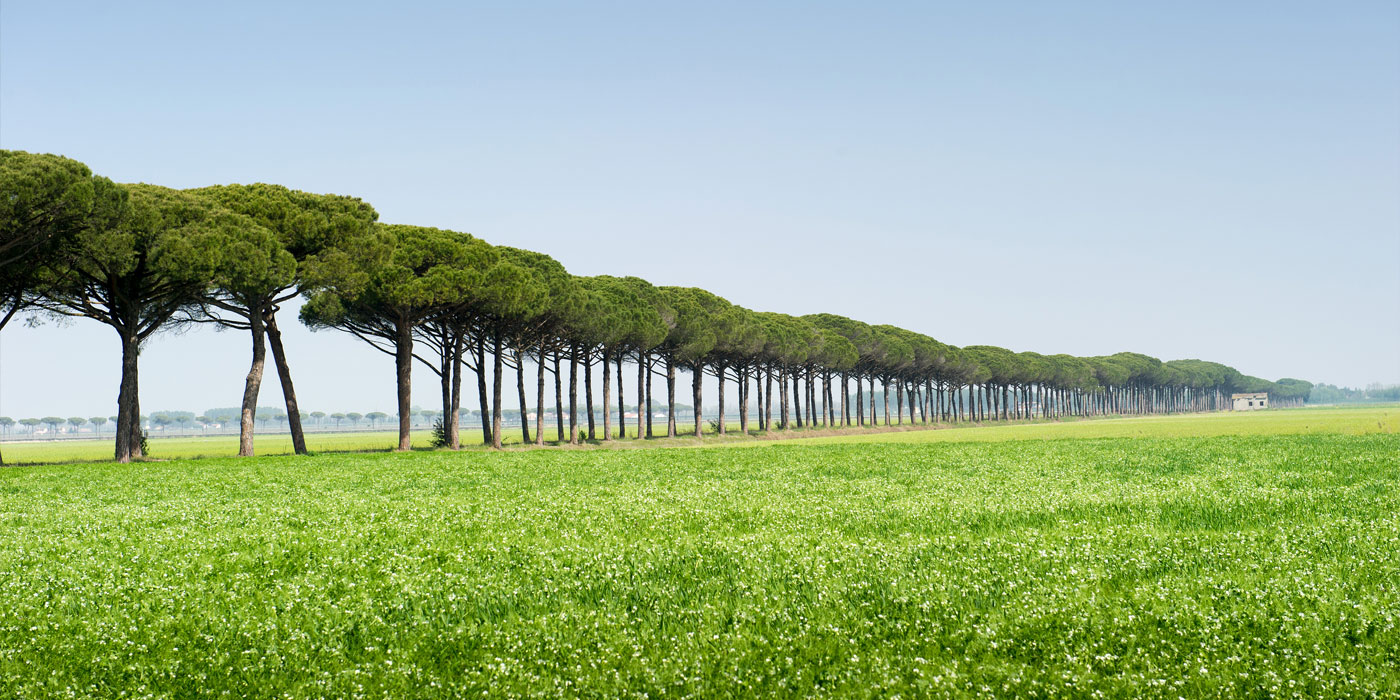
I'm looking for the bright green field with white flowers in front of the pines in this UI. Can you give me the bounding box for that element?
[0,407,1400,699]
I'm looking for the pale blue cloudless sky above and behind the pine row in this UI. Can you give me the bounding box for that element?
[0,0,1400,419]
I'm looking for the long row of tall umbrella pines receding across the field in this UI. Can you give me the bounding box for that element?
[0,151,1310,462]
